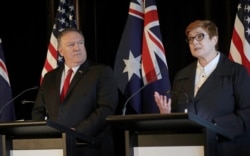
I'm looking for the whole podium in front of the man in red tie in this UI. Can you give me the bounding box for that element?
[0,120,93,156]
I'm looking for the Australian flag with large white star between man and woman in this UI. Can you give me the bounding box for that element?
[114,0,170,114]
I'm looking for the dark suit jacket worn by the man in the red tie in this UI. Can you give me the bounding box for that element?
[32,61,118,155]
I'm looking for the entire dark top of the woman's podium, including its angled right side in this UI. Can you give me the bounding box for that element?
[106,113,231,139]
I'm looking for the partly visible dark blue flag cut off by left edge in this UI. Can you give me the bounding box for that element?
[0,39,16,121]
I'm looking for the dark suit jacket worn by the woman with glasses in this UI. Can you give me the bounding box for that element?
[172,53,250,156]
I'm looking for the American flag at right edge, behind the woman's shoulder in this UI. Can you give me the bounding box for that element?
[229,0,250,74]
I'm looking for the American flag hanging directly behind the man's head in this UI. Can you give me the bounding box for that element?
[40,0,77,83]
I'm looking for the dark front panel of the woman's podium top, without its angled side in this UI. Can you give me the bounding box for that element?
[107,113,201,131]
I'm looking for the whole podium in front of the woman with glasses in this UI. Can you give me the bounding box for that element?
[106,113,230,156]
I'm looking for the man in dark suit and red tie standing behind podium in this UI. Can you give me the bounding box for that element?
[32,28,118,156]
